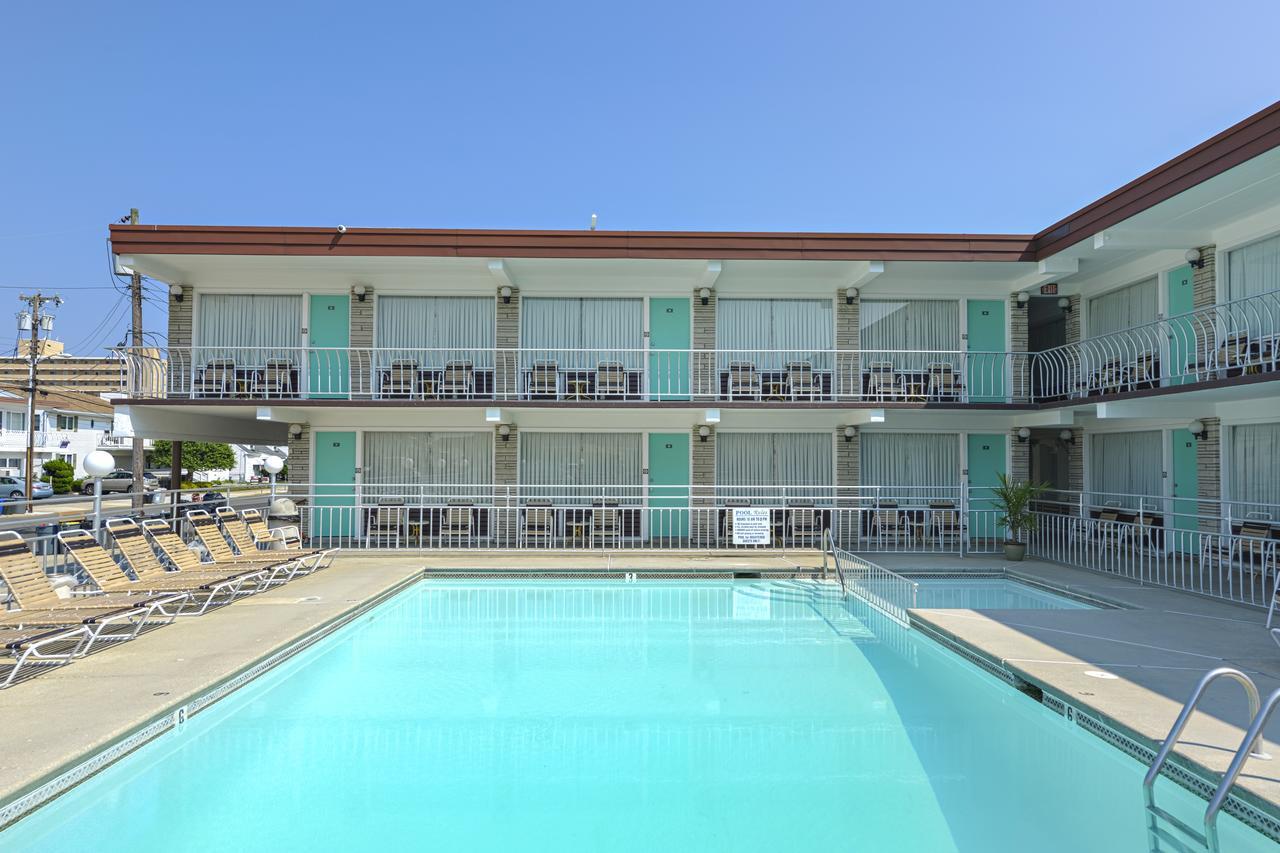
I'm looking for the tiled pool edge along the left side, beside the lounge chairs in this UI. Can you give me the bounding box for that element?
[0,573,422,833]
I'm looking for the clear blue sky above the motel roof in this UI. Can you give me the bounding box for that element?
[0,0,1280,352]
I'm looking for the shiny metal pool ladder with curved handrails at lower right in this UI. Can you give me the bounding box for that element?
[1142,666,1280,853]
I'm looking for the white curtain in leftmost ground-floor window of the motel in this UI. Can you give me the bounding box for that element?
[362,432,493,503]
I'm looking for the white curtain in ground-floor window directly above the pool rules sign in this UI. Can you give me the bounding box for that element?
[716,433,835,501]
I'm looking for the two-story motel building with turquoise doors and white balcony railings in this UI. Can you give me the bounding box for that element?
[111,105,1280,603]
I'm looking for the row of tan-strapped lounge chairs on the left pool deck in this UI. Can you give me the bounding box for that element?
[0,507,332,688]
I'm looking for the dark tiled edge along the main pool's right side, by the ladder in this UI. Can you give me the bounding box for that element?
[908,611,1280,843]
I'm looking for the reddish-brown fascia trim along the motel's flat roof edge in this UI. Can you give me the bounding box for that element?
[110,101,1280,263]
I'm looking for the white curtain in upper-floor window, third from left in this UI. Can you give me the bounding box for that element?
[520,297,644,370]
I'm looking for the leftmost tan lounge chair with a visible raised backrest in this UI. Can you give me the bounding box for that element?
[0,530,173,654]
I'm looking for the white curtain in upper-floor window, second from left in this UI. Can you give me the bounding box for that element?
[374,296,495,369]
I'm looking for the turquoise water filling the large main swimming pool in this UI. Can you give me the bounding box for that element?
[0,581,1274,853]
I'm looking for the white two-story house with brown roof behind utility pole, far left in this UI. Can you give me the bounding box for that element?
[0,387,111,476]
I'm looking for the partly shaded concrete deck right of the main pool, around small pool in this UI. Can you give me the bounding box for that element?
[868,555,1280,816]
